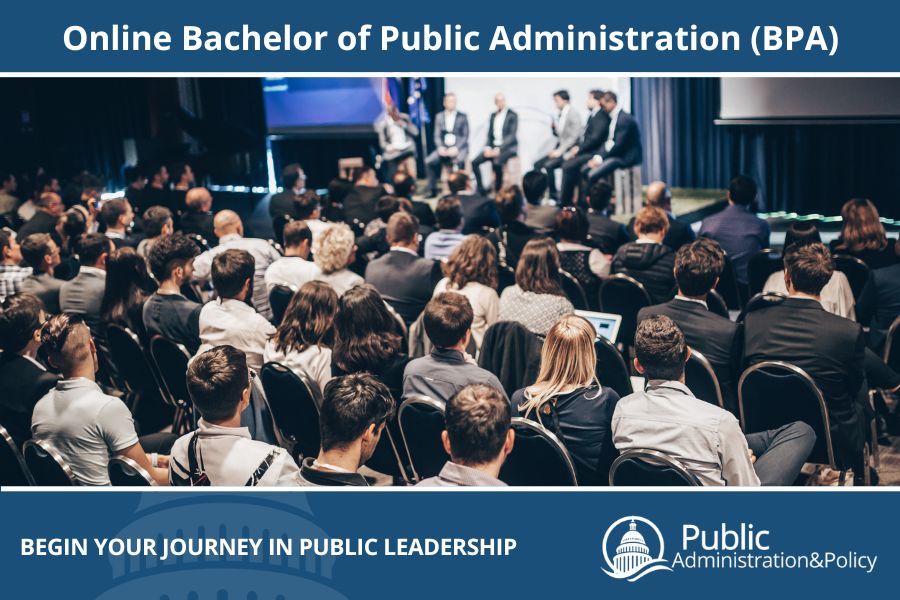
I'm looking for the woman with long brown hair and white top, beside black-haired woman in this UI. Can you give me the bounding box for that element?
[263,281,338,391]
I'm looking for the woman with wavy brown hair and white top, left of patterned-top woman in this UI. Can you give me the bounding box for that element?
[434,235,500,348]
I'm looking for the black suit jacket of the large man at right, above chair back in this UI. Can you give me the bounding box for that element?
[744,298,866,453]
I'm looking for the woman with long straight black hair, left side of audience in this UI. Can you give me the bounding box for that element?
[100,246,156,344]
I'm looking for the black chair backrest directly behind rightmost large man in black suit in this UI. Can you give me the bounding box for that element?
[738,361,839,469]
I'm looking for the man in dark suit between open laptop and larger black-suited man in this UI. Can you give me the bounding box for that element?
[638,238,737,414]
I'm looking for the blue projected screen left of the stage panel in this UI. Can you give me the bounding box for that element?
[262,77,384,135]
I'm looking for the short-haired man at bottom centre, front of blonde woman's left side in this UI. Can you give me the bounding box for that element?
[417,384,516,487]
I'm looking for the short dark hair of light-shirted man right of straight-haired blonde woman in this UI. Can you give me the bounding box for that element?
[634,315,688,381]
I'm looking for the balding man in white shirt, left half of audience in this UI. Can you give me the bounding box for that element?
[194,210,281,319]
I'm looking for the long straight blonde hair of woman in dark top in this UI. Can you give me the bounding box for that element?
[519,315,601,420]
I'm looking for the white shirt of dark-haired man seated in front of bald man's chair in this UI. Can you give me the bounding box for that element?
[197,298,275,371]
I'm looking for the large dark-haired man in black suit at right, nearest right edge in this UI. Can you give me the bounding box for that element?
[744,243,868,480]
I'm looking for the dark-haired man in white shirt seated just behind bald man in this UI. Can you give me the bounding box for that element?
[199,248,275,371]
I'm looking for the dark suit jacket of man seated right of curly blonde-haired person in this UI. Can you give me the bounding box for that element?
[366,250,443,324]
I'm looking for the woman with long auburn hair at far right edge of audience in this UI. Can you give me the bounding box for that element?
[831,198,898,269]
